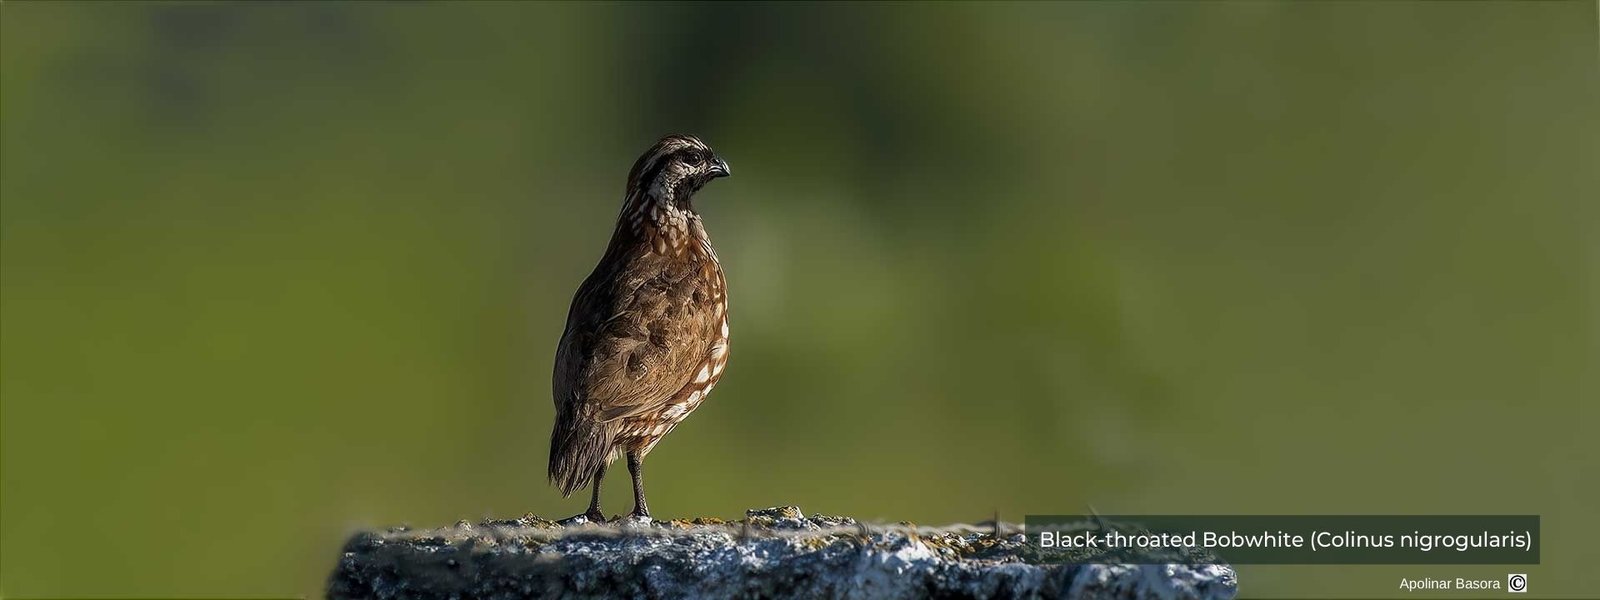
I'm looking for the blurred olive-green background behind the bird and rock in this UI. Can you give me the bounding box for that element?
[0,2,1600,597]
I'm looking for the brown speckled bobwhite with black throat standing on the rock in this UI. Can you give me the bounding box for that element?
[549,134,731,525]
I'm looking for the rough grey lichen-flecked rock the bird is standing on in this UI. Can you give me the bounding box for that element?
[328,507,1238,600]
